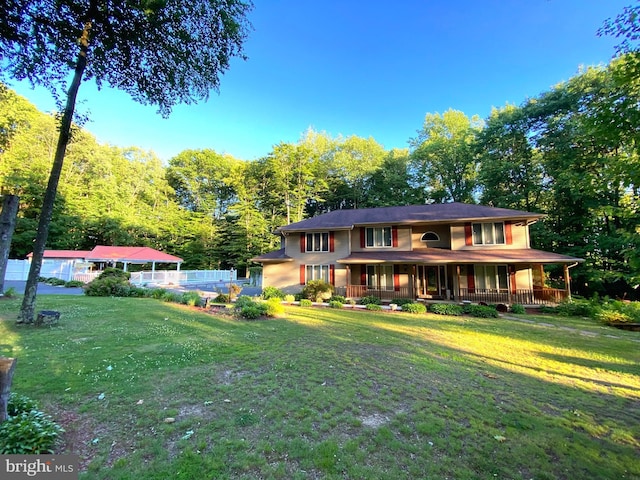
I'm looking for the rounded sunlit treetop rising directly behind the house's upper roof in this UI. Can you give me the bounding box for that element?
[409,109,482,203]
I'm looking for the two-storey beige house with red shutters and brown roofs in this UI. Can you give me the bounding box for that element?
[253,202,583,304]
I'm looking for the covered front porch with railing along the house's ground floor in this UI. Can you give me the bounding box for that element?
[336,248,578,305]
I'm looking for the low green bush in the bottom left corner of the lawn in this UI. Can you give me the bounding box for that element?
[0,393,64,455]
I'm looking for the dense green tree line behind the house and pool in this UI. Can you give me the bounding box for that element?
[0,52,640,298]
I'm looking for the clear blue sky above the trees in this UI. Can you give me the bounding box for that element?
[11,0,632,161]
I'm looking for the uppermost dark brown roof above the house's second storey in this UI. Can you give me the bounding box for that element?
[278,202,544,232]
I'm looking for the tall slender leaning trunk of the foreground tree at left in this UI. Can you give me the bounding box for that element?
[18,22,91,323]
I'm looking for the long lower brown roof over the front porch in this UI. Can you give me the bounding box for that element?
[337,248,584,265]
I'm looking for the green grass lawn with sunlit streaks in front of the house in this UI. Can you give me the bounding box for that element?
[0,296,640,480]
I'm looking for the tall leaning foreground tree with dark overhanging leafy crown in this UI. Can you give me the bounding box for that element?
[0,0,252,323]
